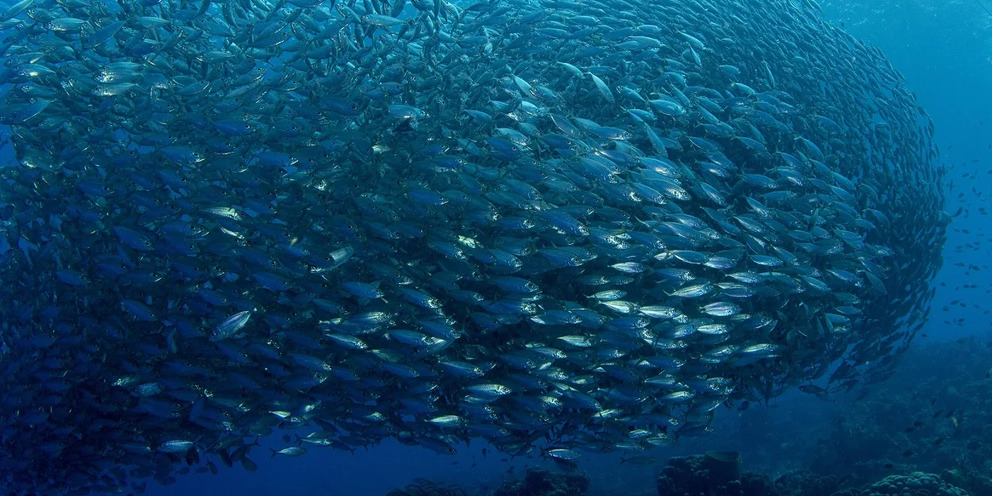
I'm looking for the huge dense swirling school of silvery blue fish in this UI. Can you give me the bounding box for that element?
[0,0,947,494]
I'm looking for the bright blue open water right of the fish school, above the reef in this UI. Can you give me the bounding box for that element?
[823,0,992,346]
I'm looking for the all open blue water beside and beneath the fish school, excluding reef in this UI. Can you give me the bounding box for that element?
[0,0,992,496]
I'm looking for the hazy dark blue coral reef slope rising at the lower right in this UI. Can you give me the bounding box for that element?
[808,339,992,484]
